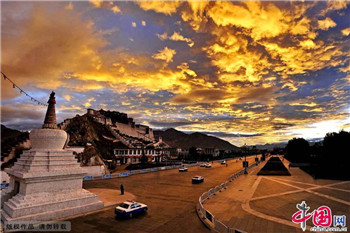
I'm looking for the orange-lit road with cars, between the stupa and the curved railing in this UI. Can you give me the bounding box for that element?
[69,157,260,233]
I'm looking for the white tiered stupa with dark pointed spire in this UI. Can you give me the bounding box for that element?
[1,92,103,222]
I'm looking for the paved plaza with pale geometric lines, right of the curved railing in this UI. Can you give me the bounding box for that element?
[204,158,350,233]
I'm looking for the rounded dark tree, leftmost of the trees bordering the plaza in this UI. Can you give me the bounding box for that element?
[286,138,310,163]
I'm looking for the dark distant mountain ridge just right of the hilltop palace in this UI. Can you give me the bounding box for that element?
[153,128,239,150]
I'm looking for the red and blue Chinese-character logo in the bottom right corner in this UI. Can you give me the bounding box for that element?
[292,201,347,232]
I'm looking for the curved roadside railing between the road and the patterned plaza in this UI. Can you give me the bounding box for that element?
[197,163,257,233]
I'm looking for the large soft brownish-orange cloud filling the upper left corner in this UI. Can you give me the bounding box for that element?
[1,2,107,95]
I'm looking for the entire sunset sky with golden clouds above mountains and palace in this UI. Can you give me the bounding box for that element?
[1,1,350,145]
